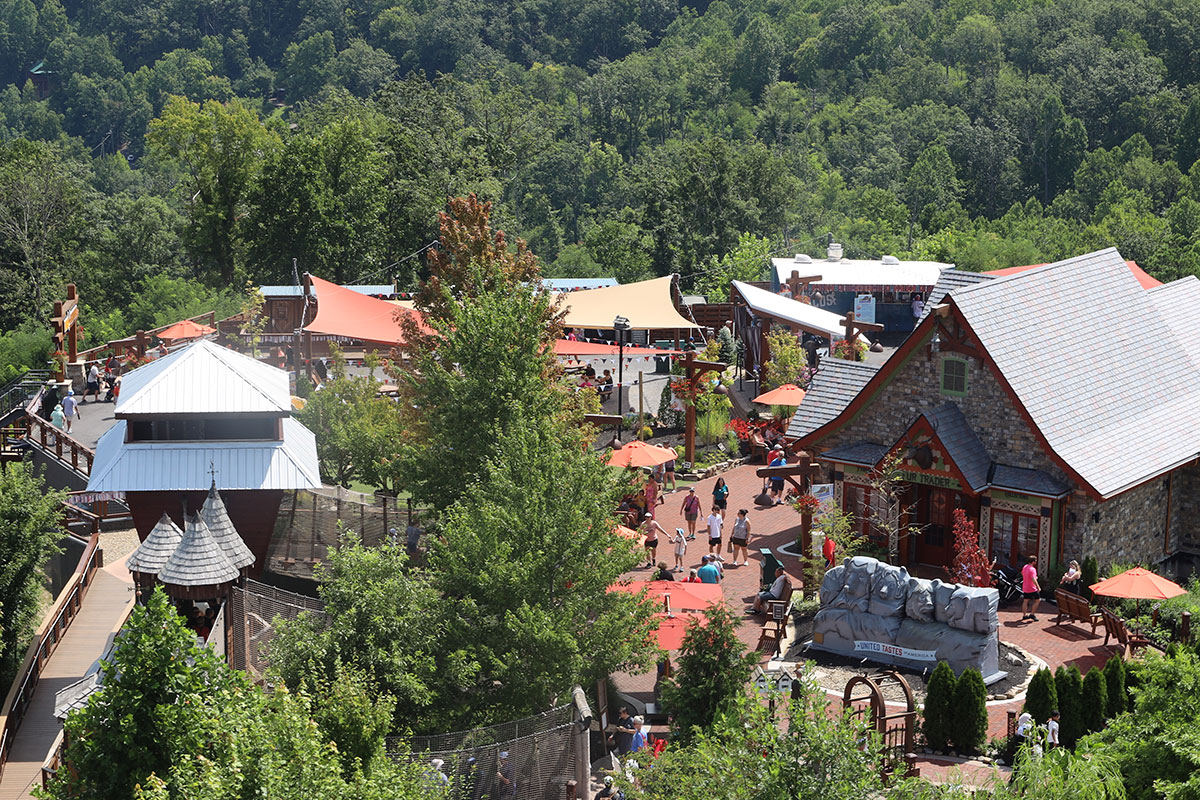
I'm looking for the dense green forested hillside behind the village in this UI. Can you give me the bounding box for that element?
[0,0,1200,365]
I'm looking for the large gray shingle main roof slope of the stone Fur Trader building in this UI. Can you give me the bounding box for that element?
[949,248,1200,498]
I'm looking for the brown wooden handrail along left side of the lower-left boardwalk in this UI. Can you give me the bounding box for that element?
[0,533,104,775]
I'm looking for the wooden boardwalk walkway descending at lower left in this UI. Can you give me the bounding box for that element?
[0,570,133,800]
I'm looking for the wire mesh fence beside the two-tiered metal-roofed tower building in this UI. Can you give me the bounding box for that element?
[266,487,414,578]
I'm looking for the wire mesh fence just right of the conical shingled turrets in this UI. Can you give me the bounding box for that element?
[223,581,325,681]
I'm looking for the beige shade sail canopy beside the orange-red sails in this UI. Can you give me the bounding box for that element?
[563,276,701,331]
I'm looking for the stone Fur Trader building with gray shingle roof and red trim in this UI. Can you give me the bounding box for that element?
[790,248,1200,575]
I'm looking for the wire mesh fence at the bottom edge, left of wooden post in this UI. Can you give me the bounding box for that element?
[388,704,580,800]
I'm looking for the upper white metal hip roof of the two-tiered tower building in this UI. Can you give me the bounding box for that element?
[114,339,292,419]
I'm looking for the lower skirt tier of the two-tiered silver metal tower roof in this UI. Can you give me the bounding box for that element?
[88,416,320,492]
